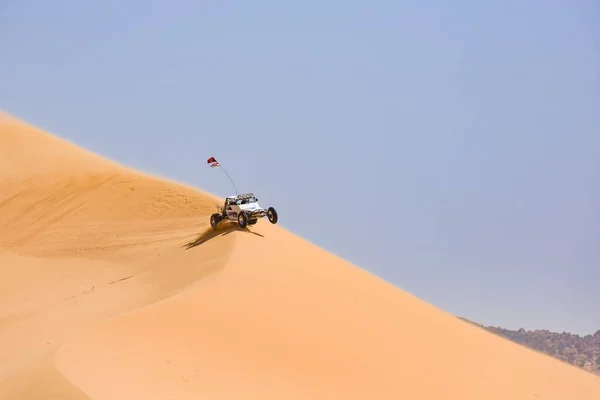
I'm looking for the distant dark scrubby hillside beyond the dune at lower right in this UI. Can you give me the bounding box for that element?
[459,317,600,375]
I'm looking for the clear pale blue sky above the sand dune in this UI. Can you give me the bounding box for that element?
[0,0,600,334]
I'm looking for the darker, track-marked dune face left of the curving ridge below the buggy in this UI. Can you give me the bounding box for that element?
[0,116,234,399]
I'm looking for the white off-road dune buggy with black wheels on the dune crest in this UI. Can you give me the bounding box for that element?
[210,193,278,230]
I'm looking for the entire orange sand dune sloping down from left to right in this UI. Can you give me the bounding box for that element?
[0,111,600,400]
